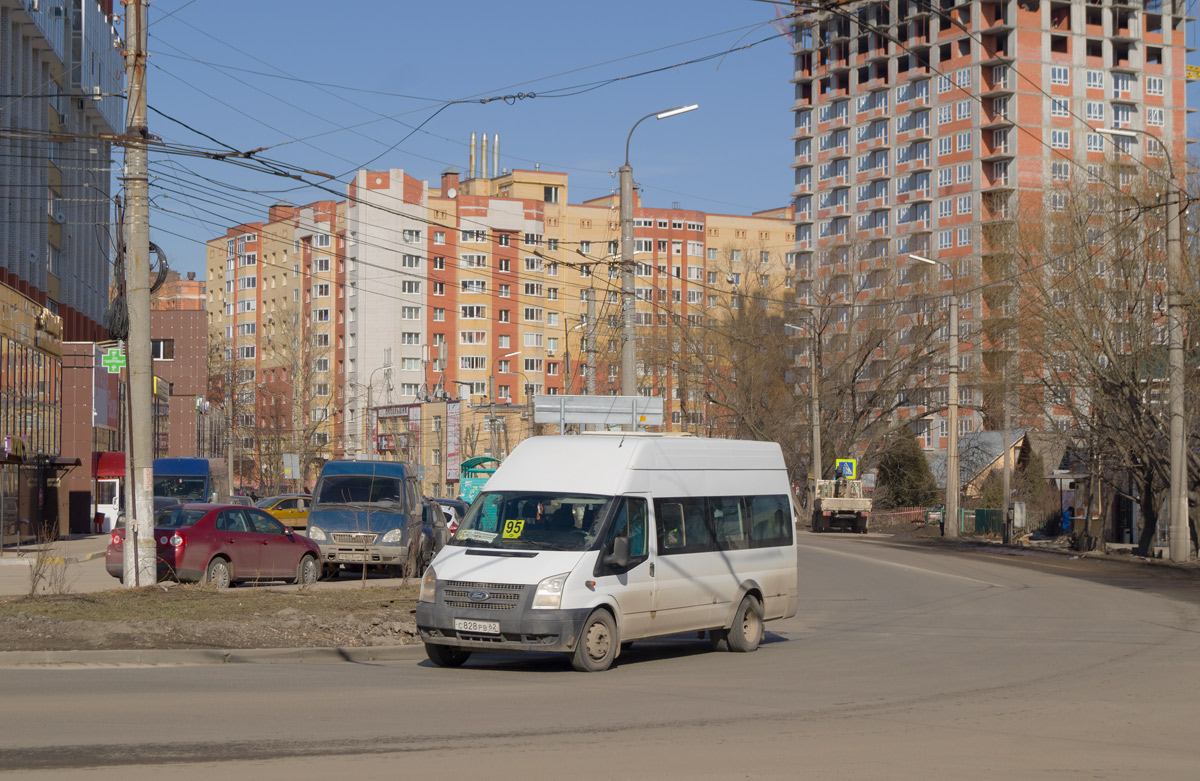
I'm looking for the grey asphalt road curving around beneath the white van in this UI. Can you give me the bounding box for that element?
[0,534,1200,780]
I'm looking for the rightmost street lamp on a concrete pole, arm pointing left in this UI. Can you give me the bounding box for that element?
[1093,127,1192,561]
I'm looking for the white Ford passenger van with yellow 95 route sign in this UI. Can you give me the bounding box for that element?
[416,433,798,671]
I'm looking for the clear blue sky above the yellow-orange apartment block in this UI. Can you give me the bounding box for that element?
[148,0,792,276]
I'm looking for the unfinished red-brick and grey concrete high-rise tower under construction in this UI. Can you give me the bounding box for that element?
[792,0,1188,450]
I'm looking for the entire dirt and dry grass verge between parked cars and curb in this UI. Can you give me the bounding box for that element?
[0,585,418,651]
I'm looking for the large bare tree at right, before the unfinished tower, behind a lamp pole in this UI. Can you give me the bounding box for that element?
[1012,160,1200,555]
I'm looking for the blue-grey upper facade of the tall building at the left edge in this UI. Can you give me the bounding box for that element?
[0,0,124,341]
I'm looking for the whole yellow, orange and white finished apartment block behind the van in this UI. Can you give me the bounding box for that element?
[208,146,794,488]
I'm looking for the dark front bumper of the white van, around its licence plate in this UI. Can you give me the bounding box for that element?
[416,592,592,651]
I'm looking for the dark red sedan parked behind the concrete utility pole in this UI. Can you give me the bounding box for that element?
[104,504,320,588]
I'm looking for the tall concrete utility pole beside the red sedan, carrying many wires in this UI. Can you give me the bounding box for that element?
[124,0,157,588]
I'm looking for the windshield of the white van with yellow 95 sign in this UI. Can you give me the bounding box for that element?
[449,491,613,551]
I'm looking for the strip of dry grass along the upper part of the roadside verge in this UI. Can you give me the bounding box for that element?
[0,585,416,621]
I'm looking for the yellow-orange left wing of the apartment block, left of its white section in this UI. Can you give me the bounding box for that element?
[205,200,353,485]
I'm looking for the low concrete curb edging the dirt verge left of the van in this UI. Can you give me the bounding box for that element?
[0,644,425,668]
